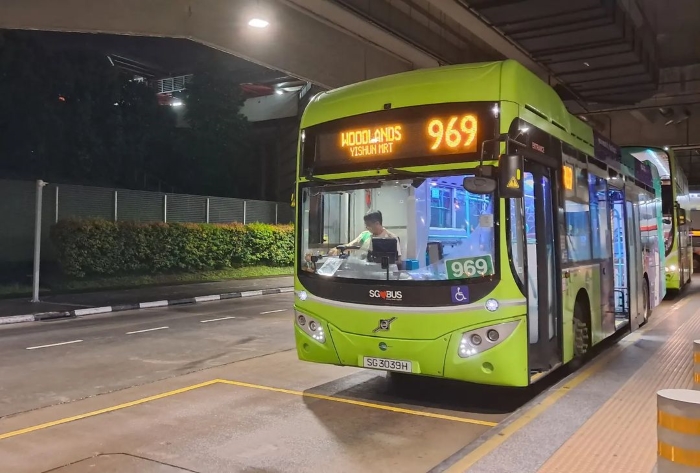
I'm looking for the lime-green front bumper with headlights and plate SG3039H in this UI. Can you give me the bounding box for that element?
[295,316,530,386]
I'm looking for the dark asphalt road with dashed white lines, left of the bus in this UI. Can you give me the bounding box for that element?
[0,294,294,417]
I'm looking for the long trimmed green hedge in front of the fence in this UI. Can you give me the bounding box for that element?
[51,220,294,278]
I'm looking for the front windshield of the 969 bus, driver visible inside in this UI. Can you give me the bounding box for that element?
[299,175,496,282]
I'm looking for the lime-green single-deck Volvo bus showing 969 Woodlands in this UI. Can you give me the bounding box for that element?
[294,60,661,387]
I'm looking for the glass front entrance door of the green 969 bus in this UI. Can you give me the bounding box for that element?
[524,161,561,373]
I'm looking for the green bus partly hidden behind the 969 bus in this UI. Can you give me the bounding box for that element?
[622,146,693,296]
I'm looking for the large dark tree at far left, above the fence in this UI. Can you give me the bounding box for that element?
[0,33,175,187]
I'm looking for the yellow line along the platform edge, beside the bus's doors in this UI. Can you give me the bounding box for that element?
[445,299,688,473]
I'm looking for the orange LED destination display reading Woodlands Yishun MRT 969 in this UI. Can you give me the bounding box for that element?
[303,103,496,170]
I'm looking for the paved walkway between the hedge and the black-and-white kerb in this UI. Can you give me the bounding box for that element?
[0,276,293,317]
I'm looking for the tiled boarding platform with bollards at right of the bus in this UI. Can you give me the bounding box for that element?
[431,282,700,473]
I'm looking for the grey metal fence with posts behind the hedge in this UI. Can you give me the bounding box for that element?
[0,179,294,263]
